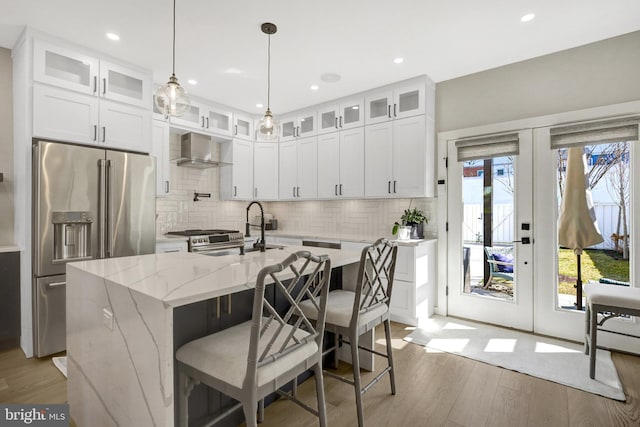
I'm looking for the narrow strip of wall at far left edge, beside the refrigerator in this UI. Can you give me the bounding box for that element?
[0,48,14,246]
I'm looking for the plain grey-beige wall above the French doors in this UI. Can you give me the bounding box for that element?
[436,31,640,132]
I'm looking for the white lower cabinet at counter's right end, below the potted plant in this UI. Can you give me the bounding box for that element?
[390,240,437,326]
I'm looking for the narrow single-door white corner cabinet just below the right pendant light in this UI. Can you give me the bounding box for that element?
[253,142,278,200]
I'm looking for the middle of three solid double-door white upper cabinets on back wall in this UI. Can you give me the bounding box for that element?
[318,127,365,199]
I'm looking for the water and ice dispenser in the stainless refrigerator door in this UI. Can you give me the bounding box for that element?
[51,211,93,264]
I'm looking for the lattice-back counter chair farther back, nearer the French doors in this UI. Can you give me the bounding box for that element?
[300,239,398,427]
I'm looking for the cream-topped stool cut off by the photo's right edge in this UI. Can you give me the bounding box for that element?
[584,283,640,379]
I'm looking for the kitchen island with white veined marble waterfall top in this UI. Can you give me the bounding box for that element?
[67,246,360,427]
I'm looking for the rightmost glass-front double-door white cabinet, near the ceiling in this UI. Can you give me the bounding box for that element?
[365,79,425,125]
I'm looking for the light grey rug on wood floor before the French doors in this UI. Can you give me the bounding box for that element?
[405,316,625,401]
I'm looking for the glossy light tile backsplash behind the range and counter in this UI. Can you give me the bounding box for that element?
[156,135,437,237]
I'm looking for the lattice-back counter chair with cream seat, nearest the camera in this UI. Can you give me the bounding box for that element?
[176,251,331,427]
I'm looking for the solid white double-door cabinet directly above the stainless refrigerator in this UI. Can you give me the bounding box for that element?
[33,83,151,153]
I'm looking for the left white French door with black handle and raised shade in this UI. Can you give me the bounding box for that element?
[447,129,534,331]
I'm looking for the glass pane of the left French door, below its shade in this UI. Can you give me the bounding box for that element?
[462,157,515,301]
